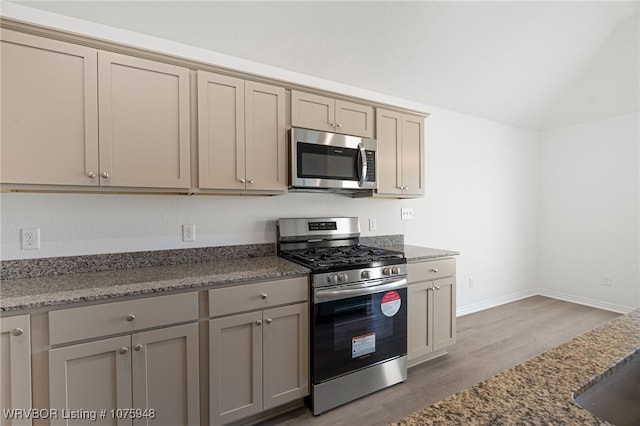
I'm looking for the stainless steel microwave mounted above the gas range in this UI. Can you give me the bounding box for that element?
[289,127,377,190]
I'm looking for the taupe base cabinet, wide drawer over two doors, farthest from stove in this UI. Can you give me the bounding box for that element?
[48,292,200,426]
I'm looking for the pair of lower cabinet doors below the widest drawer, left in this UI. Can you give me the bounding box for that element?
[49,323,199,426]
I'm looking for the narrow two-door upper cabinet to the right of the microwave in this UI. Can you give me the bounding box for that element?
[376,108,424,198]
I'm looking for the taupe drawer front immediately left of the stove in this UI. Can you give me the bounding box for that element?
[209,277,309,317]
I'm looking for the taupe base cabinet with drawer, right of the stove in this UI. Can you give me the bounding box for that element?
[407,259,456,366]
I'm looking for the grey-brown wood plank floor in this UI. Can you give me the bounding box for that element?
[264,296,620,426]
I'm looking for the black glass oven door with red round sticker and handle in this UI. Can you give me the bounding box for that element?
[311,278,407,384]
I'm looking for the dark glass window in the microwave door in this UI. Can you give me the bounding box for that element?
[296,142,359,180]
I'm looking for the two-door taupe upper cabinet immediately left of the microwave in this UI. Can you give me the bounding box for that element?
[198,71,287,193]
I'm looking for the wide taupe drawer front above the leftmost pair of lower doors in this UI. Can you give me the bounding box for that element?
[49,292,198,345]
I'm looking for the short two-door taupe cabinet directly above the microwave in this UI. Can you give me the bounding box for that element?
[291,90,374,138]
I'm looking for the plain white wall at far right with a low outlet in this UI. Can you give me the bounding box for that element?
[540,113,640,311]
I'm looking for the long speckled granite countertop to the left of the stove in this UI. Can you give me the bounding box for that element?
[0,256,309,315]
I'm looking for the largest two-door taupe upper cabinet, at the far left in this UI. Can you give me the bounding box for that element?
[1,30,191,188]
